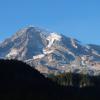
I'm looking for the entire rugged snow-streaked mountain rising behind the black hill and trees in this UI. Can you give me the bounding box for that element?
[0,26,100,75]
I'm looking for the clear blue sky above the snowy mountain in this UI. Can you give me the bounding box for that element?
[0,0,100,45]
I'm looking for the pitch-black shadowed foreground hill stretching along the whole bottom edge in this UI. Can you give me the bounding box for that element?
[0,60,100,100]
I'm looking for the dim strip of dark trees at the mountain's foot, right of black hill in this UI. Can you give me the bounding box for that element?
[48,72,100,88]
